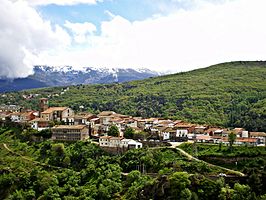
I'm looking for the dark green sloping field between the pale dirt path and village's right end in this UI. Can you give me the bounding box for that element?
[180,143,266,176]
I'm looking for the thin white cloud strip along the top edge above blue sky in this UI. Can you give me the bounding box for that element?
[27,0,99,6]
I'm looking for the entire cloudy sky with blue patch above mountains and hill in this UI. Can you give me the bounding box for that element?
[0,0,266,78]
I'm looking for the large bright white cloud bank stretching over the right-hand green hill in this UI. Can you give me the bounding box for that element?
[38,0,266,71]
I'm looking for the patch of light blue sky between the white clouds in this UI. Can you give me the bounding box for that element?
[37,0,193,32]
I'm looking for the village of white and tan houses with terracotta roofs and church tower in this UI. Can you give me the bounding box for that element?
[0,98,266,149]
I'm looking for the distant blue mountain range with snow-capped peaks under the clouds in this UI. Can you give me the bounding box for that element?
[0,66,160,92]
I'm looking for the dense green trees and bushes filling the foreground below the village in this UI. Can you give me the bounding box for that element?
[0,126,266,200]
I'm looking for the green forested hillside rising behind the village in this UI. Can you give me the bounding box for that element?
[1,62,266,131]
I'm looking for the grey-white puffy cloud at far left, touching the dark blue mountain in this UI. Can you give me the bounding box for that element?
[0,0,70,78]
